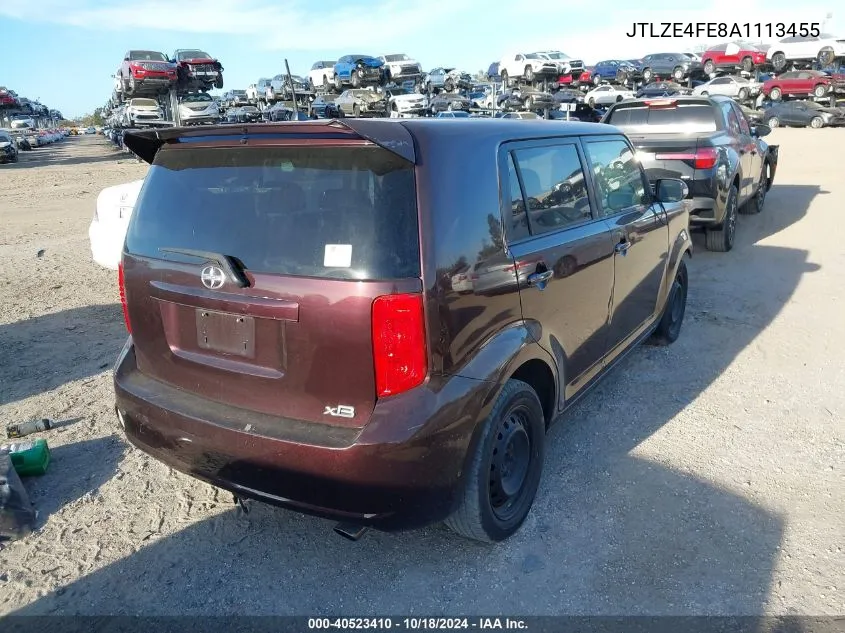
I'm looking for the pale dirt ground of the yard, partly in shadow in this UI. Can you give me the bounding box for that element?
[0,129,845,615]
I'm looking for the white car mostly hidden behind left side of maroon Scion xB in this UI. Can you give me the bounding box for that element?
[88,179,144,270]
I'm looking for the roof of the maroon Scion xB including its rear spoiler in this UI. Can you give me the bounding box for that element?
[124,117,620,163]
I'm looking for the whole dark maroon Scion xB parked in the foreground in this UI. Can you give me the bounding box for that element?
[114,119,691,541]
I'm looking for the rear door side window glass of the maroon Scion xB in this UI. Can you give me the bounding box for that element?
[512,143,592,235]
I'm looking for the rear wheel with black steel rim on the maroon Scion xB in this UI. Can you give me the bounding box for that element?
[444,379,546,543]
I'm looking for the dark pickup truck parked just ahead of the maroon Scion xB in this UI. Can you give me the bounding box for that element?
[602,95,778,252]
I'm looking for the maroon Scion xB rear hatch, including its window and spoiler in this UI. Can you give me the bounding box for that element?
[122,121,422,427]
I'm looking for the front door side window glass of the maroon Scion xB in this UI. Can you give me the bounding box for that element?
[586,139,646,216]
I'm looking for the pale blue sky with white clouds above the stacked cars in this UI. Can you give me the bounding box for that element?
[0,0,845,118]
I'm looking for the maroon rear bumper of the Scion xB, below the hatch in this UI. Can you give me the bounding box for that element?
[114,339,484,531]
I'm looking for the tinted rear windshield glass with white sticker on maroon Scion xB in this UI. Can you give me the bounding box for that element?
[126,145,420,279]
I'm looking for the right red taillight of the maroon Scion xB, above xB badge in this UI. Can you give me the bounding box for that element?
[372,294,428,398]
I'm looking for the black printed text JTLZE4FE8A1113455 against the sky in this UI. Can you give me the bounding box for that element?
[625,22,821,39]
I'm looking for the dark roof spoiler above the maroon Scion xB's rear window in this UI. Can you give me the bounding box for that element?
[123,119,417,164]
